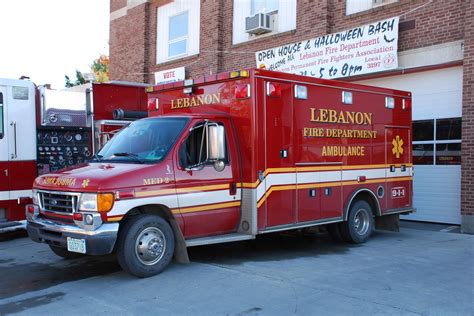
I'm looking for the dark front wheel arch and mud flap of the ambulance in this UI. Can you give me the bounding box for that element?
[119,204,189,263]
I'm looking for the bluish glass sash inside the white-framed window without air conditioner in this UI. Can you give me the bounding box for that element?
[168,12,188,58]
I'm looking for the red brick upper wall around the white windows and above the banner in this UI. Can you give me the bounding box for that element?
[110,0,466,82]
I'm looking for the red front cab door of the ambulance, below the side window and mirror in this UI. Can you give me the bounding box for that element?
[175,119,241,239]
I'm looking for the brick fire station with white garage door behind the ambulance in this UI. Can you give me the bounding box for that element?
[110,0,474,233]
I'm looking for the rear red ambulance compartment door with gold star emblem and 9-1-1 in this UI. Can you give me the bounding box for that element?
[385,127,412,212]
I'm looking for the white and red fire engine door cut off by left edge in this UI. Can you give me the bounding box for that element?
[0,87,10,222]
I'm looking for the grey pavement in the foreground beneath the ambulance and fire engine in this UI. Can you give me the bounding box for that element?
[0,222,474,316]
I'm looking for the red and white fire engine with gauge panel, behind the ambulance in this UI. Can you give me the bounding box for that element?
[0,79,147,232]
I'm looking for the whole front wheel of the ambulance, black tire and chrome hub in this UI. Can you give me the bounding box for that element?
[117,214,175,278]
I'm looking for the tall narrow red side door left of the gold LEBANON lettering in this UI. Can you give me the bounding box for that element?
[264,81,296,227]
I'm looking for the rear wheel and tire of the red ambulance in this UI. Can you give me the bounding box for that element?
[340,200,374,244]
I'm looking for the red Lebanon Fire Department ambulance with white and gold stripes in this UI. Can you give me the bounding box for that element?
[26,69,413,277]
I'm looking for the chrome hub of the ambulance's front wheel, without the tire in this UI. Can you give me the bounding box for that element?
[135,227,166,265]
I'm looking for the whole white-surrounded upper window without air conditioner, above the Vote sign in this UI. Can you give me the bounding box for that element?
[156,0,201,64]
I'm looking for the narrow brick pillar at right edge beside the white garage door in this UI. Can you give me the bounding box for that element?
[461,1,474,233]
